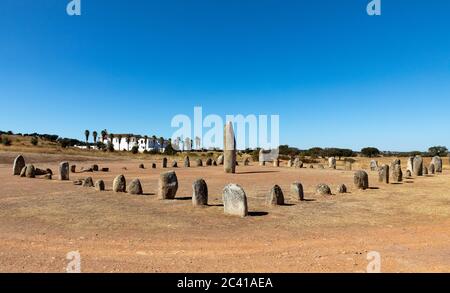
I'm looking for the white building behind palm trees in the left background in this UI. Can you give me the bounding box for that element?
[100,134,168,153]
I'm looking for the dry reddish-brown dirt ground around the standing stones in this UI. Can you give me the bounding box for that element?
[0,152,450,272]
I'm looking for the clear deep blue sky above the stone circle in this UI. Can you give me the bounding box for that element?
[0,0,450,150]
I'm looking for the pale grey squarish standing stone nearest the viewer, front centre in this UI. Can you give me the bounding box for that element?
[222,184,248,217]
